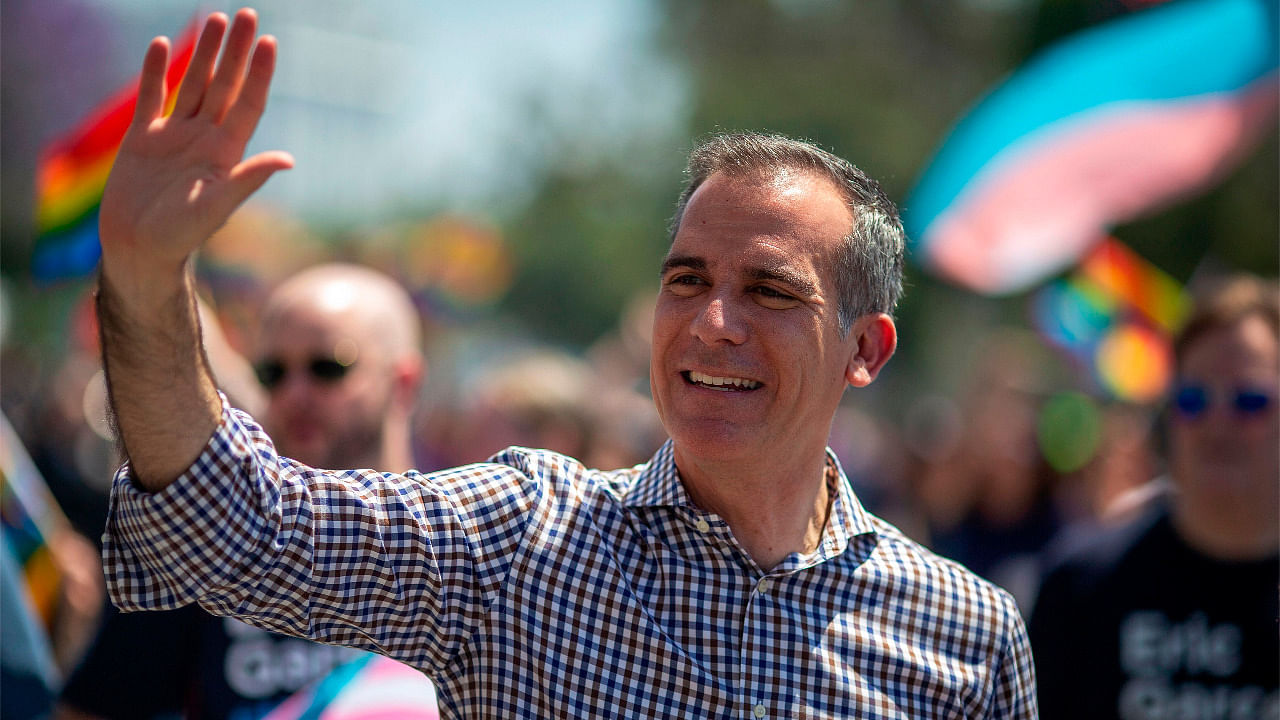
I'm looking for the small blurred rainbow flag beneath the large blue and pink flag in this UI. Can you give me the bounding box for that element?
[1032,238,1190,402]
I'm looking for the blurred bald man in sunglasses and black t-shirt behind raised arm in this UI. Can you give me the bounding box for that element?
[58,264,434,720]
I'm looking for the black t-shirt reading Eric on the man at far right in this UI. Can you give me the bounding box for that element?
[1029,509,1280,720]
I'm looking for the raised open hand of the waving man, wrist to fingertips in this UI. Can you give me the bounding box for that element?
[99,8,293,292]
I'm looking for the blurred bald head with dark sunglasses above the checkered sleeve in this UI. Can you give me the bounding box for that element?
[253,264,425,471]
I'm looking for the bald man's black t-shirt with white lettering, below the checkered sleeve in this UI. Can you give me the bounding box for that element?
[61,606,360,720]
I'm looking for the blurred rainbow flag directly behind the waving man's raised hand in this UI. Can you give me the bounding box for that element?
[31,23,198,282]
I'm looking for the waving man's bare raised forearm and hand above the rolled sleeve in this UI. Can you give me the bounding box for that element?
[97,9,293,491]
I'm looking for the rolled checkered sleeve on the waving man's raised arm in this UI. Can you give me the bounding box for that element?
[102,397,541,670]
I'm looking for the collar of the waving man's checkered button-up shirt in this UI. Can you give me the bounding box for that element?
[625,439,876,545]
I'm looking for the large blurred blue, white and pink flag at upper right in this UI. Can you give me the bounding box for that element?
[904,0,1280,293]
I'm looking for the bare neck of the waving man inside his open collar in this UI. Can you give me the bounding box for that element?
[676,448,832,570]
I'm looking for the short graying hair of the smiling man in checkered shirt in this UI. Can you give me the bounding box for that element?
[669,133,906,332]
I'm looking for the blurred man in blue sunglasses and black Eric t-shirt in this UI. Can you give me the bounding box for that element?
[1030,275,1280,720]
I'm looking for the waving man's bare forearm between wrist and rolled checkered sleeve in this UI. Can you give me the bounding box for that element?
[97,257,221,491]
